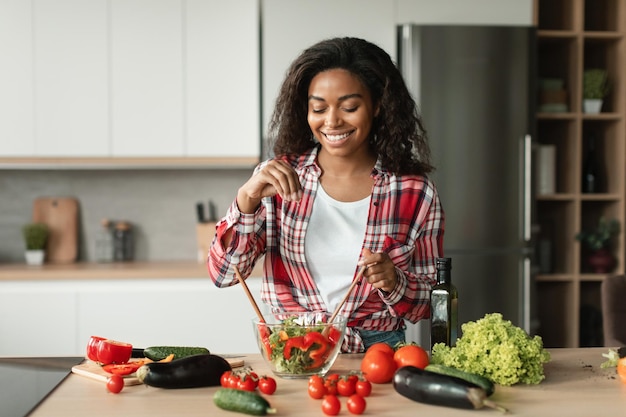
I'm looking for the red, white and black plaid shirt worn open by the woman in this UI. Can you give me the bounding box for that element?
[207,149,444,352]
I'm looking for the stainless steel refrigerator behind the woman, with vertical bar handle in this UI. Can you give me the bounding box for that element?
[398,25,538,334]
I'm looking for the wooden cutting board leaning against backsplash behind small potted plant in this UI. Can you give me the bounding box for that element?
[33,197,78,263]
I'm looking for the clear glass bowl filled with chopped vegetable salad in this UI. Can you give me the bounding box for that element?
[253,312,346,378]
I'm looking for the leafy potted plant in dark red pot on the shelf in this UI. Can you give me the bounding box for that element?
[576,217,620,274]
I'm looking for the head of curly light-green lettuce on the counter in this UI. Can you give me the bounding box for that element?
[431,313,550,386]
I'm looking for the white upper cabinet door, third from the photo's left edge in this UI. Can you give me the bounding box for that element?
[110,0,185,156]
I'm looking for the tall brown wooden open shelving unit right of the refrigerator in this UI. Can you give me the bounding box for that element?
[534,0,626,347]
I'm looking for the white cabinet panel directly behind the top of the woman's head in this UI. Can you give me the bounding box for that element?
[262,0,396,136]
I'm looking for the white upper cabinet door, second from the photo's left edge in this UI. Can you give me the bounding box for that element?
[33,0,109,156]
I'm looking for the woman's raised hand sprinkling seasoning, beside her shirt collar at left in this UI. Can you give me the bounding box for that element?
[237,159,302,213]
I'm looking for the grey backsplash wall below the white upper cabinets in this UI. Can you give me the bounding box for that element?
[0,169,252,263]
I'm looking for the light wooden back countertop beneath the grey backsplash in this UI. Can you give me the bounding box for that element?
[0,259,263,282]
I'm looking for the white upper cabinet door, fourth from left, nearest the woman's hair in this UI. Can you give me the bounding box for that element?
[185,0,261,158]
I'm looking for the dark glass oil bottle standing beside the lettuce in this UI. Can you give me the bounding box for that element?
[430,258,459,351]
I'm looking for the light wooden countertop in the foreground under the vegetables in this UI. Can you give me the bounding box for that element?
[24,348,626,417]
